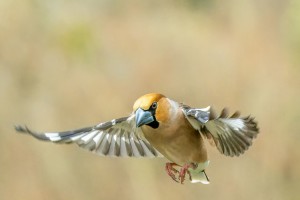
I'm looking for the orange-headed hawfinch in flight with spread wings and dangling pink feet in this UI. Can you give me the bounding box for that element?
[15,93,259,184]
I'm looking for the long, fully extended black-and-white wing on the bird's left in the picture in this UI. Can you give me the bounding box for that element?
[15,115,161,157]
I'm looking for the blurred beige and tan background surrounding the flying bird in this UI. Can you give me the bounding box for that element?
[0,0,300,200]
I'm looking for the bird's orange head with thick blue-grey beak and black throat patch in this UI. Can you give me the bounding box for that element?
[133,93,169,128]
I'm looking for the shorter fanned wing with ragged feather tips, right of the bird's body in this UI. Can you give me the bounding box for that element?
[182,106,259,156]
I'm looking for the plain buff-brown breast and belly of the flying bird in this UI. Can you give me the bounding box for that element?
[142,112,207,165]
